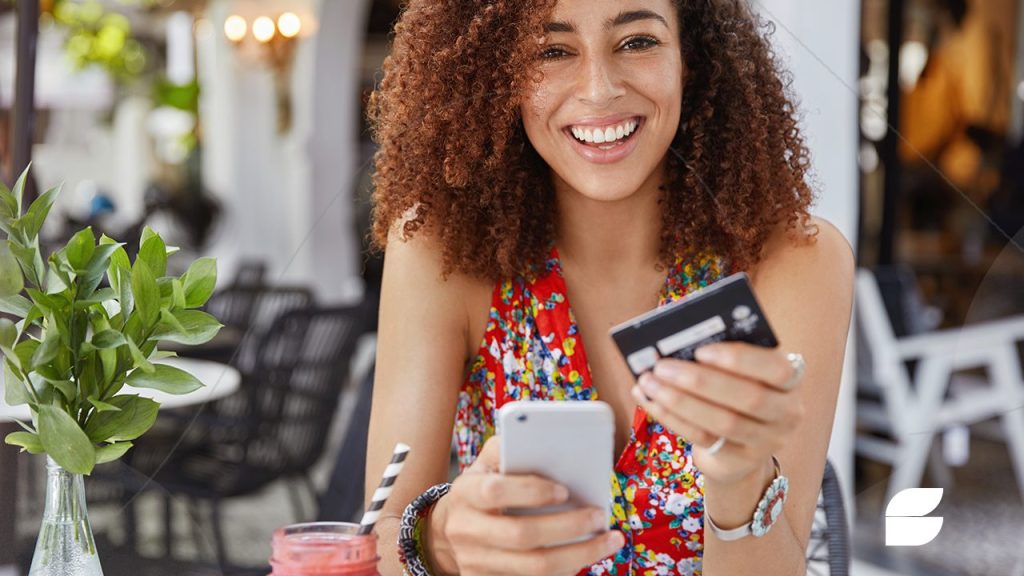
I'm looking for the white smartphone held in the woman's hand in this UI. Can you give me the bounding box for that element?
[497,401,615,517]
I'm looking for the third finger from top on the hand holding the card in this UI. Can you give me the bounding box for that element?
[640,373,767,445]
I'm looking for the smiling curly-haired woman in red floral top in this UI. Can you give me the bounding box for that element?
[367,0,853,576]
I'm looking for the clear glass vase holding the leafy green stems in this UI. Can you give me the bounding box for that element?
[29,456,103,576]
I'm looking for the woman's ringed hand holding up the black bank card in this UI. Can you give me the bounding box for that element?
[633,342,804,484]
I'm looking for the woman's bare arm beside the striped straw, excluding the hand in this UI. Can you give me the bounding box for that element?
[366,226,468,574]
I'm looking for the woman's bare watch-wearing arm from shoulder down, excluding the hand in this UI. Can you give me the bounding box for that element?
[705,216,853,575]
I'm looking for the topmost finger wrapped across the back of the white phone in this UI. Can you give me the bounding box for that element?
[465,474,569,511]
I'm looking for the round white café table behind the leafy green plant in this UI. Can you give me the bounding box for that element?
[0,358,242,576]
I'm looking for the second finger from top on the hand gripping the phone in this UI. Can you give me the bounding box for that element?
[463,507,610,551]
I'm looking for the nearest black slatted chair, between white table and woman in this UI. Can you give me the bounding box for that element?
[132,306,365,567]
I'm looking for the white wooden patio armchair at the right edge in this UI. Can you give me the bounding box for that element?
[855,269,1024,502]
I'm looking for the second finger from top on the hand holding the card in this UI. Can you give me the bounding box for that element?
[653,359,793,422]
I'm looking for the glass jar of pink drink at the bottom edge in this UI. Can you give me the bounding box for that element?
[270,522,380,576]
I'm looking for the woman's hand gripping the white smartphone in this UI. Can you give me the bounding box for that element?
[424,437,625,576]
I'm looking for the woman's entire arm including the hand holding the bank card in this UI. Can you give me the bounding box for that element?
[634,217,853,576]
